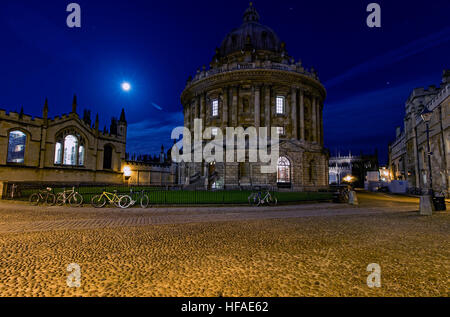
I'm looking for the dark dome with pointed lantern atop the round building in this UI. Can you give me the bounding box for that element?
[219,3,281,56]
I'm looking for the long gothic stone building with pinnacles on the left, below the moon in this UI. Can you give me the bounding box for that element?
[0,97,127,197]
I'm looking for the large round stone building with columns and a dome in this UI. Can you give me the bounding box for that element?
[179,4,328,191]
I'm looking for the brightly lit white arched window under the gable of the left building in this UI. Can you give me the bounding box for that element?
[54,129,85,166]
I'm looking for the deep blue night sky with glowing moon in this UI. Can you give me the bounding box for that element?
[0,0,450,162]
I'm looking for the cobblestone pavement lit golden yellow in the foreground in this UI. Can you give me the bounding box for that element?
[0,193,450,297]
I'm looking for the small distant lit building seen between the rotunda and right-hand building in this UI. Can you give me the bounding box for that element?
[328,151,379,187]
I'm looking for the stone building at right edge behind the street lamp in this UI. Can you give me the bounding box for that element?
[389,70,450,196]
